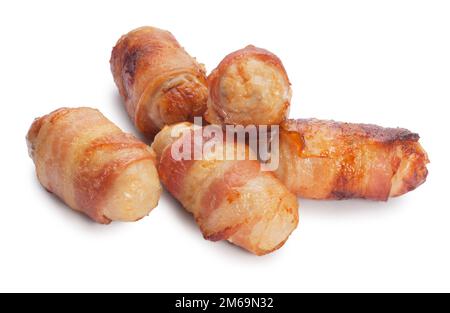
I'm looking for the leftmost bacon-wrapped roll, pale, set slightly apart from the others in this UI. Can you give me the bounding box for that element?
[27,108,161,224]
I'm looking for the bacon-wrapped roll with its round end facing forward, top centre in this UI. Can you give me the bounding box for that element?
[205,46,291,126]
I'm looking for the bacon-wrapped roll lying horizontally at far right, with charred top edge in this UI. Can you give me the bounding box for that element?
[275,119,429,200]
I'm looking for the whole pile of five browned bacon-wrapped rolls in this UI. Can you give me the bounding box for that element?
[27,27,429,255]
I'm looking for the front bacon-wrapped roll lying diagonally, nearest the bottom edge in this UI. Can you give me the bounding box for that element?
[152,123,298,255]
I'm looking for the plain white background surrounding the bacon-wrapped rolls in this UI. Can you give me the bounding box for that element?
[0,0,450,292]
